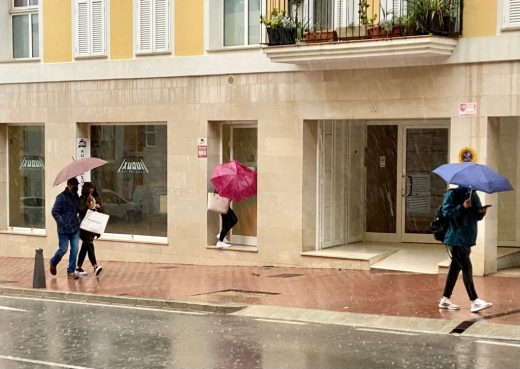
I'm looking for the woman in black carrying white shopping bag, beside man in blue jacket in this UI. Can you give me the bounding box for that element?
[76,182,103,275]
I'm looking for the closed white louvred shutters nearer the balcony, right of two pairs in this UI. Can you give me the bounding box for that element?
[136,0,172,54]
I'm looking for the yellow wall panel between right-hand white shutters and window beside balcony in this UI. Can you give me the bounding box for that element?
[174,0,204,56]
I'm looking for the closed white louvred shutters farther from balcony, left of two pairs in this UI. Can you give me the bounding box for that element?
[74,0,107,57]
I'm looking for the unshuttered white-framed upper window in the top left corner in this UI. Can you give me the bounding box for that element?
[10,0,40,59]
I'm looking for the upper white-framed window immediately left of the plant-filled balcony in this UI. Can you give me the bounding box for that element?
[223,0,261,46]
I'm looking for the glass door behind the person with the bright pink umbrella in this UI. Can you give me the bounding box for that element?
[222,124,258,246]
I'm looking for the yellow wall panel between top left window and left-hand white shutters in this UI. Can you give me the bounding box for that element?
[41,0,72,63]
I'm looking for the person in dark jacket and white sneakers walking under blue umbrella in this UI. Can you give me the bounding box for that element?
[439,187,493,313]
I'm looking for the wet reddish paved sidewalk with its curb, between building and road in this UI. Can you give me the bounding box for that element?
[0,256,520,340]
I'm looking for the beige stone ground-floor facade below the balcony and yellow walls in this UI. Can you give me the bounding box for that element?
[0,0,520,275]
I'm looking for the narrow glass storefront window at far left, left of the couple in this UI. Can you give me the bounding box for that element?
[7,126,45,228]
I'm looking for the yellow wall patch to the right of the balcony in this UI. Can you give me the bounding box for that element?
[462,0,498,37]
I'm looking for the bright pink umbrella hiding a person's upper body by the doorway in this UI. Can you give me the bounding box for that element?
[211,160,256,201]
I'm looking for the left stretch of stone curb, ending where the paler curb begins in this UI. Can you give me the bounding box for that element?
[0,287,246,314]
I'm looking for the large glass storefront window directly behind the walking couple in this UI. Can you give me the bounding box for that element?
[90,125,167,237]
